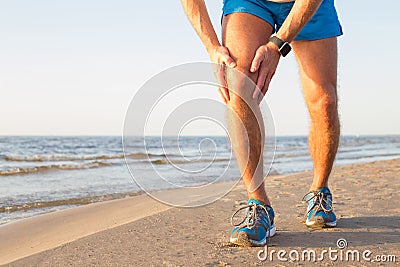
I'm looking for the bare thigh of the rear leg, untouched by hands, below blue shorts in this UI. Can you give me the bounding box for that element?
[293,37,337,105]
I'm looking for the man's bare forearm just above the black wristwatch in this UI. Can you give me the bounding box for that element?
[276,0,322,42]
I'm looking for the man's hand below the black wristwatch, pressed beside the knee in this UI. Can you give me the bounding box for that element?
[250,43,281,103]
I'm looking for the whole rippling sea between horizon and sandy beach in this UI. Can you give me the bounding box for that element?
[0,136,400,224]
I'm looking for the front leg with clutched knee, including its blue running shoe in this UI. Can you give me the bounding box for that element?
[223,13,275,246]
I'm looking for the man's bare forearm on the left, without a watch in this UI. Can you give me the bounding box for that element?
[181,0,220,53]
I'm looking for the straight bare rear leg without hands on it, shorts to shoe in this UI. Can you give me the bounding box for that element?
[293,37,340,193]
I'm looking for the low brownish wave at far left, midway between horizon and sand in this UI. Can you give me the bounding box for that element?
[0,161,111,176]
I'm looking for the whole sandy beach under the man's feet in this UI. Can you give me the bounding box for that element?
[0,159,400,266]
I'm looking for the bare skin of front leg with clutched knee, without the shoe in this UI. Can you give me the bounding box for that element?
[223,13,272,205]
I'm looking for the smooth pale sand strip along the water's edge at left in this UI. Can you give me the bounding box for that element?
[0,181,241,265]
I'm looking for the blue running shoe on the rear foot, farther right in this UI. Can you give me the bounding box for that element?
[303,187,336,228]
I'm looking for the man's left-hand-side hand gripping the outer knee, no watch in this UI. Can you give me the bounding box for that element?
[210,46,236,104]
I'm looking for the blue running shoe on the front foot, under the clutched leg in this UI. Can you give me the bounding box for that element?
[230,199,275,247]
